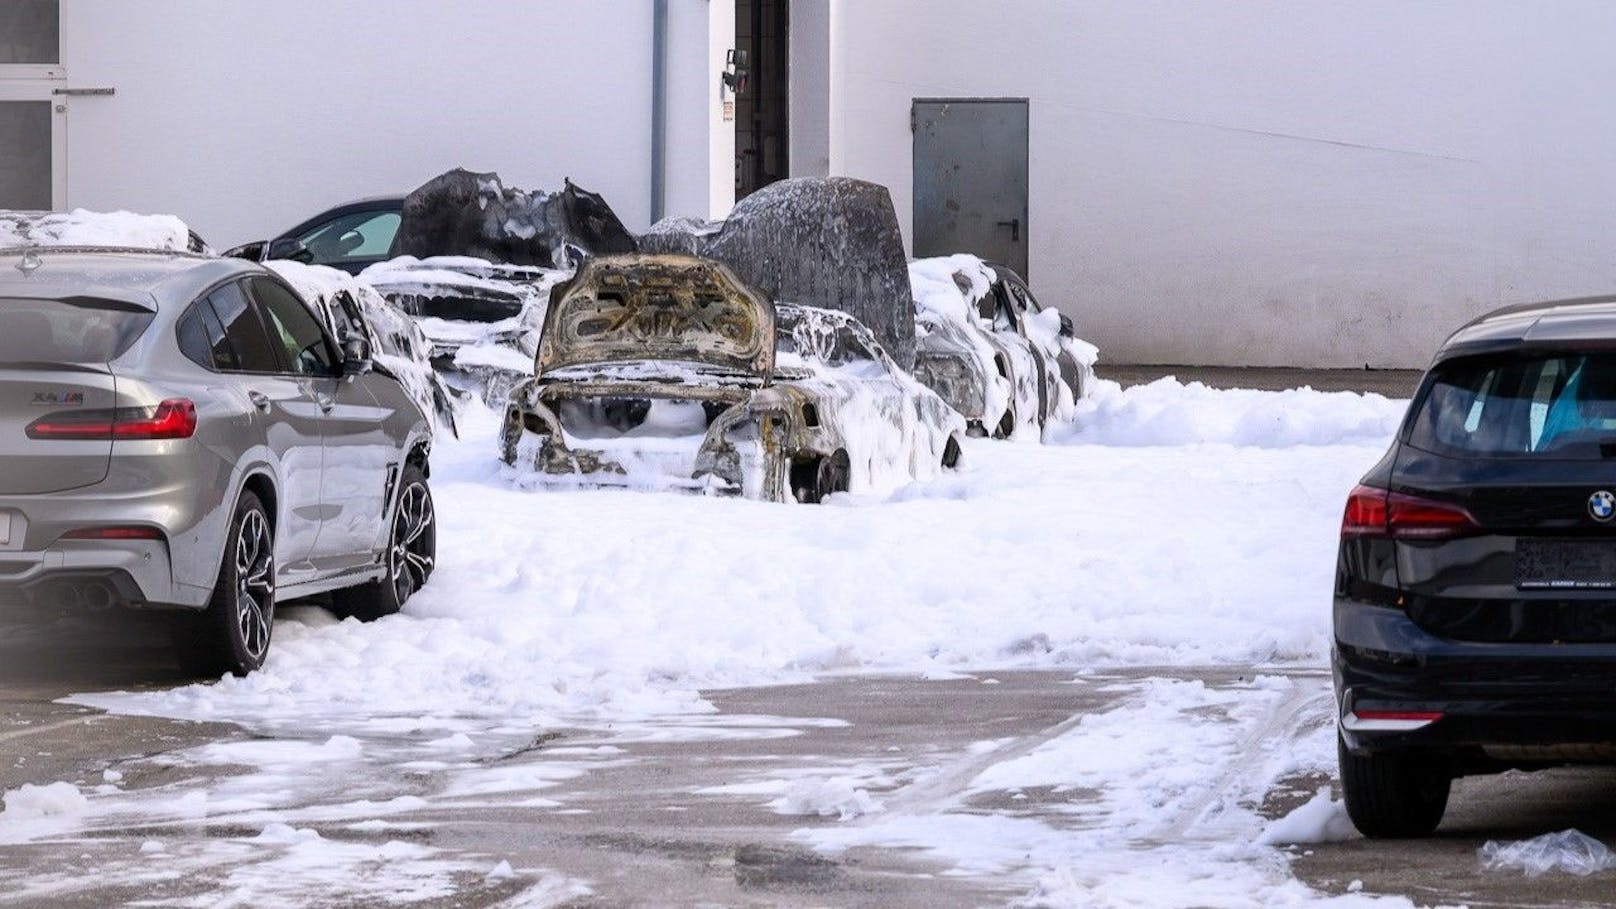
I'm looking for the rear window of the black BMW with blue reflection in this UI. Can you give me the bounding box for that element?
[1409,353,1616,458]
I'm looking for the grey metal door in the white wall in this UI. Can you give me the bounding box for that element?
[910,99,1028,277]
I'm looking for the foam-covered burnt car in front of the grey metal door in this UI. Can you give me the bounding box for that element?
[910,256,1096,438]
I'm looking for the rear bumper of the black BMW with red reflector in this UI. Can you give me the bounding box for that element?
[1332,598,1616,762]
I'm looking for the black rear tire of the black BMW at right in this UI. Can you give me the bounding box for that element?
[1336,736,1453,839]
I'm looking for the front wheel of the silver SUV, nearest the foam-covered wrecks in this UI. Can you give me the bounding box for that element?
[331,463,438,621]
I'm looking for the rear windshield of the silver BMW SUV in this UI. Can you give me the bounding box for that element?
[0,298,154,364]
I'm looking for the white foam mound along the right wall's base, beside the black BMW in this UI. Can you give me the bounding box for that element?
[1046,377,1408,448]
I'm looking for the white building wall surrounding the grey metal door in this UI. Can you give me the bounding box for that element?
[829,0,1616,367]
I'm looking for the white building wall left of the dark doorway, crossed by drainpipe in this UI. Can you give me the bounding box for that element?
[61,0,734,246]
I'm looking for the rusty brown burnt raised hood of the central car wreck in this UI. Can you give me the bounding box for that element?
[538,256,774,385]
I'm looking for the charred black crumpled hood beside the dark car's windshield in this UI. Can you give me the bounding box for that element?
[394,168,638,268]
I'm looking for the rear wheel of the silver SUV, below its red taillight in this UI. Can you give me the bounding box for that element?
[170,492,275,678]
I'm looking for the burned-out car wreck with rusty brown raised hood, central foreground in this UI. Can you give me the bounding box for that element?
[501,256,965,501]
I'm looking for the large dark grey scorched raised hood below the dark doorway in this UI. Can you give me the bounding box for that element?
[640,176,915,369]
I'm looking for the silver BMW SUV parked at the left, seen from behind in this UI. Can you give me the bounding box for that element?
[0,247,436,676]
